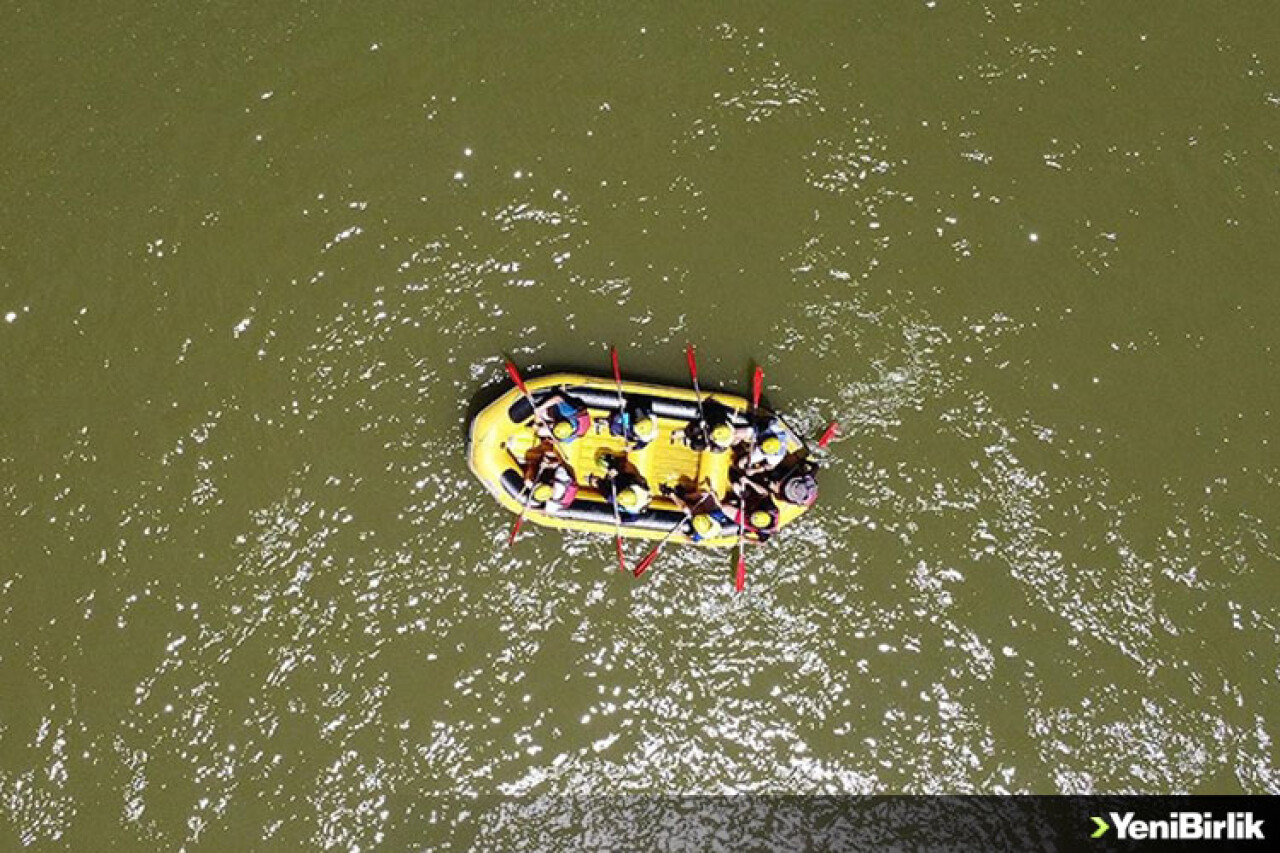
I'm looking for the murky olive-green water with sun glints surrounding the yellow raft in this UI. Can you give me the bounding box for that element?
[0,0,1280,850]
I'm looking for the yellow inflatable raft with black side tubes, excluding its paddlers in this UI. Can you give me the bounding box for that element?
[467,373,808,547]
